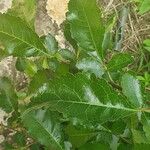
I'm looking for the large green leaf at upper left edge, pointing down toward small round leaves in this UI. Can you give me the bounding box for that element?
[0,14,46,56]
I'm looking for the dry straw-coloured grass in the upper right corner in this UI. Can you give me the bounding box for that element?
[100,0,150,54]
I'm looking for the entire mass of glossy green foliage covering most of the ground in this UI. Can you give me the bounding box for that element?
[0,0,150,150]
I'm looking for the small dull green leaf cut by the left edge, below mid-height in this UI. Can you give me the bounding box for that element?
[0,77,18,112]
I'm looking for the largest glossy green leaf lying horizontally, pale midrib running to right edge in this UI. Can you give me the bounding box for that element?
[24,74,137,123]
